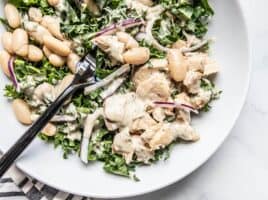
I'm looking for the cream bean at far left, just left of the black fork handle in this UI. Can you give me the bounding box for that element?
[12,99,32,125]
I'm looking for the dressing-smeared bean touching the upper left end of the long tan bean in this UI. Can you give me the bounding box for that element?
[24,22,51,44]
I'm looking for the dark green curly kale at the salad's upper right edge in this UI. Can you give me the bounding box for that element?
[154,0,214,39]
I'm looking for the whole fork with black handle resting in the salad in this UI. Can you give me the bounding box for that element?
[0,54,96,177]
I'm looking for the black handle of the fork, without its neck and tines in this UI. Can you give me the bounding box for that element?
[0,85,76,177]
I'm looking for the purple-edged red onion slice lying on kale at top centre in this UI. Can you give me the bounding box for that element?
[92,18,144,38]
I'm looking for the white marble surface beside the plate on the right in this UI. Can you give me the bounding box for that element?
[102,0,268,200]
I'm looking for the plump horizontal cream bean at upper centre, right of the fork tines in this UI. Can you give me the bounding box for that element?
[123,47,150,65]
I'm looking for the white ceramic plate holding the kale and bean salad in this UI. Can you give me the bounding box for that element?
[0,0,250,199]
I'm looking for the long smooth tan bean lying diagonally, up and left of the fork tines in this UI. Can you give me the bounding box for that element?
[43,36,71,56]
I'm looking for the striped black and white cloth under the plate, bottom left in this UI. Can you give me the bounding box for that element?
[0,154,92,200]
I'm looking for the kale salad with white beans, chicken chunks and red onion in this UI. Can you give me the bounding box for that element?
[0,0,220,180]
